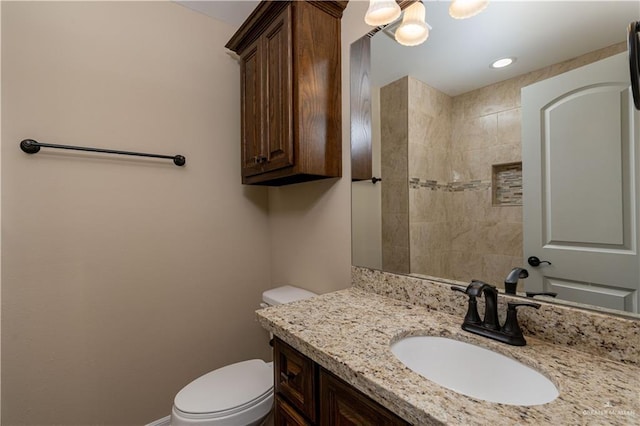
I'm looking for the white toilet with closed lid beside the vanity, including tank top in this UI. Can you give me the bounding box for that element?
[171,286,316,426]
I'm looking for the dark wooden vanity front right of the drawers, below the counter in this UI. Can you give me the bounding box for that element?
[320,370,409,426]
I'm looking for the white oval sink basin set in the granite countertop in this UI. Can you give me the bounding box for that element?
[391,336,559,405]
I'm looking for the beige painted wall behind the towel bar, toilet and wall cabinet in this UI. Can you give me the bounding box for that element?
[2,2,272,425]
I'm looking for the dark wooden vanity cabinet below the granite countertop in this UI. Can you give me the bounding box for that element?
[273,338,409,426]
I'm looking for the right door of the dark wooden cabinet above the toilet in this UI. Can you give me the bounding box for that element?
[262,5,294,171]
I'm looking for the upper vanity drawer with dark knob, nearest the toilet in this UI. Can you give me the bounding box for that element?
[273,339,318,424]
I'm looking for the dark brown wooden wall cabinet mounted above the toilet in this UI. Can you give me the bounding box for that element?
[226,1,347,186]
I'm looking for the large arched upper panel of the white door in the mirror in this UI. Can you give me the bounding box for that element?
[542,84,630,248]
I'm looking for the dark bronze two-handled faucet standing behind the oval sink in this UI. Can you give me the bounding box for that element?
[451,280,540,346]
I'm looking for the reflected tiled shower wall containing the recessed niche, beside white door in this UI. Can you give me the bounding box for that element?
[444,76,524,285]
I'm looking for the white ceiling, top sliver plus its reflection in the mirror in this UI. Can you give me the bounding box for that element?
[178,0,640,95]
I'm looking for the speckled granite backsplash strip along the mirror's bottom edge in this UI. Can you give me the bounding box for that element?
[351,266,640,365]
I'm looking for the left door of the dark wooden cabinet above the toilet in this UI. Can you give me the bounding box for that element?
[240,39,263,177]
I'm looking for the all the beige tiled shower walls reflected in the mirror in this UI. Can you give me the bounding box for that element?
[380,43,626,286]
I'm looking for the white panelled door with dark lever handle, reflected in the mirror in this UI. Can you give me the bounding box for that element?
[522,53,640,312]
